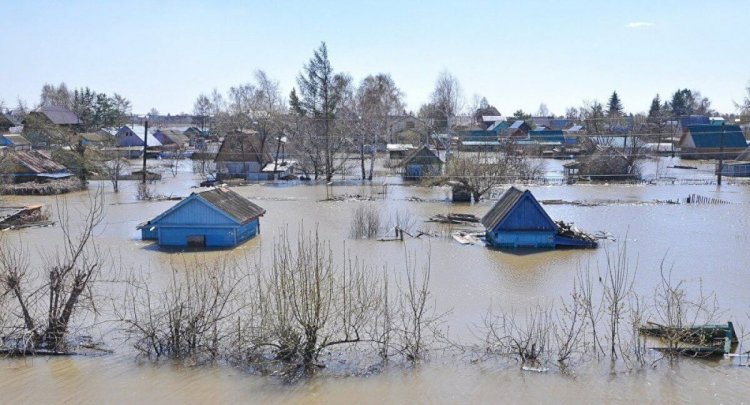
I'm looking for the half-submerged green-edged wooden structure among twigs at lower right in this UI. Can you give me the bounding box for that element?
[638,322,739,356]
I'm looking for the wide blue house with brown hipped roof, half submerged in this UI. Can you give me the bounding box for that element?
[137,187,266,248]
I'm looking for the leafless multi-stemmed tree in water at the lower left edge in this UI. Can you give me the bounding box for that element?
[0,189,104,354]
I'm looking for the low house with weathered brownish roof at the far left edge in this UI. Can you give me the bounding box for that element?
[0,150,72,183]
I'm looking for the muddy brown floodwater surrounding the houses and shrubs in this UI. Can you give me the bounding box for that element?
[0,158,750,403]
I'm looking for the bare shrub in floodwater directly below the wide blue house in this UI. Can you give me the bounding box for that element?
[114,260,246,361]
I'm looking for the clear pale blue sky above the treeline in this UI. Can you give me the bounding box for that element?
[0,0,750,115]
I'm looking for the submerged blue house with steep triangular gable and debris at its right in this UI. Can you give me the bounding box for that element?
[481,187,597,249]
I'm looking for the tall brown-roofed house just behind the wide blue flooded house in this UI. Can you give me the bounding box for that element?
[214,131,273,181]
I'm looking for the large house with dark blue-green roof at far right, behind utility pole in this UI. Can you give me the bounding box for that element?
[679,124,747,159]
